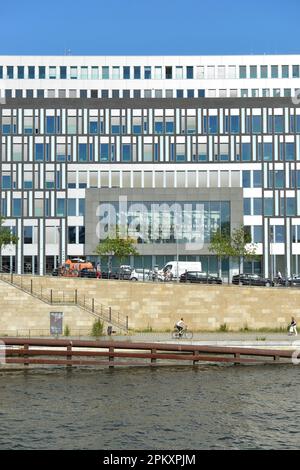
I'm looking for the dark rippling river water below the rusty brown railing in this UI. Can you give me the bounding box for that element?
[0,365,300,450]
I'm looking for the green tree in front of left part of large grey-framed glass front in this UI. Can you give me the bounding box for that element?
[95,233,139,271]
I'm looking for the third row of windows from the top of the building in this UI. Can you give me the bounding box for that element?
[1,108,300,135]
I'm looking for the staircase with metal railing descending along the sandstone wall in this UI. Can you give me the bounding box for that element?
[0,271,128,333]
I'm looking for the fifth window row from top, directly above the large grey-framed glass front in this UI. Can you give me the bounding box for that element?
[0,168,300,192]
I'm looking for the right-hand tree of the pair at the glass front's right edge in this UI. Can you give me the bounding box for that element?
[231,225,257,274]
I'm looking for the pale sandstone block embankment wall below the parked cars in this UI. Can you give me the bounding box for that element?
[0,276,300,331]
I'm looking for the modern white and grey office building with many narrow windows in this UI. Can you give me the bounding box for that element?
[0,55,300,277]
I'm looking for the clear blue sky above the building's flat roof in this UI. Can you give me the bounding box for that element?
[0,0,300,55]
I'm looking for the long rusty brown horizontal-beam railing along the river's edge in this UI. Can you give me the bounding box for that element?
[0,337,294,367]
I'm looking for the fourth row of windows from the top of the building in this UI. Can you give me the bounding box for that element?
[2,141,300,163]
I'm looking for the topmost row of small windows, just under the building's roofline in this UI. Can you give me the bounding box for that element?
[0,64,300,80]
